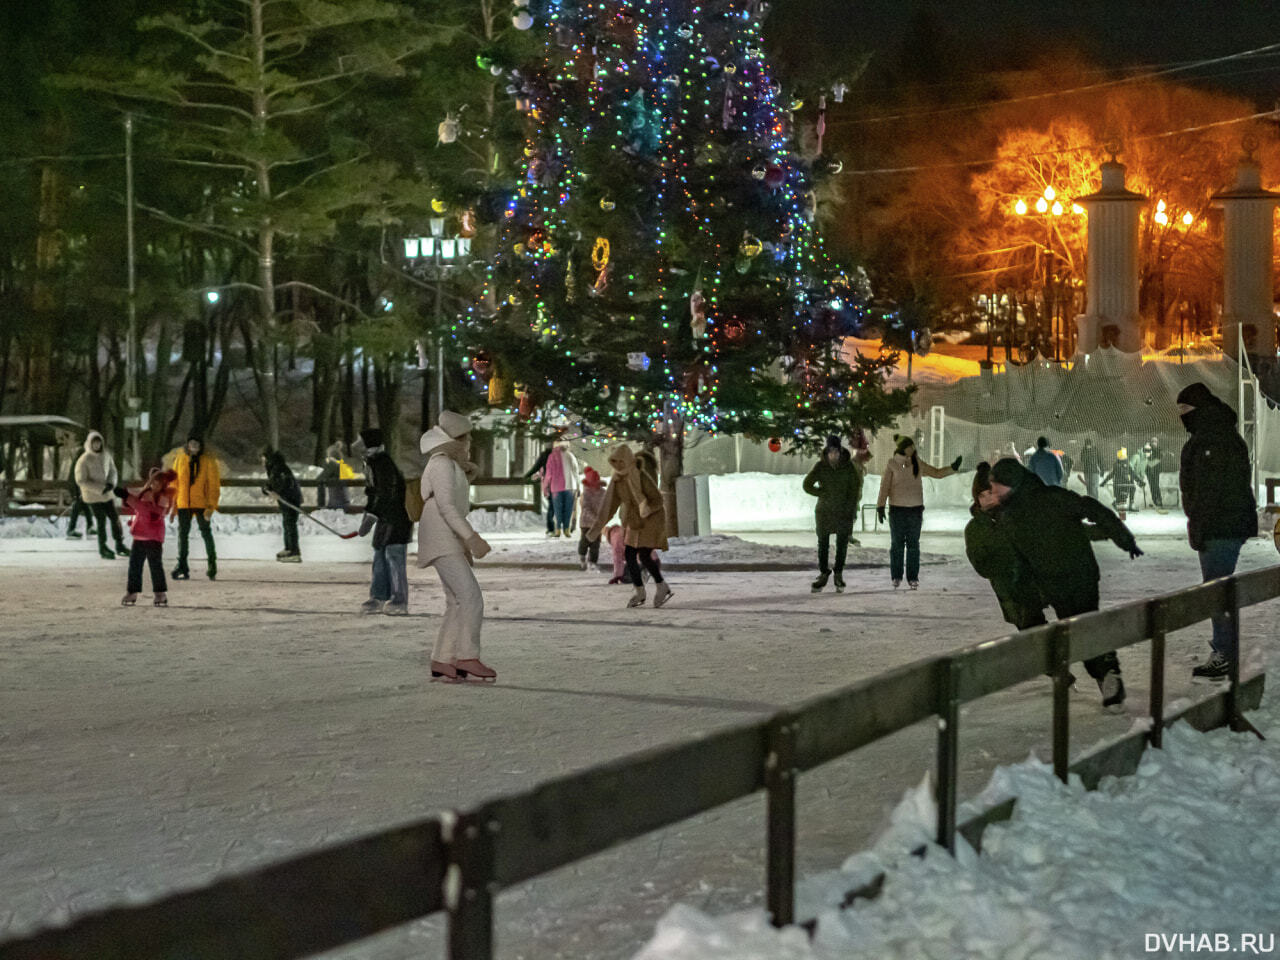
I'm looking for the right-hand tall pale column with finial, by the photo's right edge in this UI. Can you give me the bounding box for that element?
[1212,156,1280,358]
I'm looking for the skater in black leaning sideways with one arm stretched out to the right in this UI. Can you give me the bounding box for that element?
[991,458,1142,709]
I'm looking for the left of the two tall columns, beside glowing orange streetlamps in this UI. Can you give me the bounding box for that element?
[1075,156,1147,353]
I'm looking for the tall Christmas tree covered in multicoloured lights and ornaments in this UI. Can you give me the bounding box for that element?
[470,0,909,463]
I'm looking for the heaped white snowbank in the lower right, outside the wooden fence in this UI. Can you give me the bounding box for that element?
[636,698,1280,960]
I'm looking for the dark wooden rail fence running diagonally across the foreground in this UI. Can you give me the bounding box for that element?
[0,566,1280,960]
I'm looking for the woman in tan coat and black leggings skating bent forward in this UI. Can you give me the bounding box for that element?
[586,444,671,607]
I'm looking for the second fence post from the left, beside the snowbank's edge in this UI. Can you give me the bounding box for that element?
[764,713,796,927]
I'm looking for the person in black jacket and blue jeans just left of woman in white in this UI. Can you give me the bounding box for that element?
[360,428,413,614]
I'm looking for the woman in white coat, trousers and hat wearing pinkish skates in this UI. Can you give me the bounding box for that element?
[417,410,498,682]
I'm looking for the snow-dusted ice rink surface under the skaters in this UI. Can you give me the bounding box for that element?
[0,535,1280,960]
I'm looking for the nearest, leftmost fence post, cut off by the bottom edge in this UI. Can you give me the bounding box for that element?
[440,810,499,960]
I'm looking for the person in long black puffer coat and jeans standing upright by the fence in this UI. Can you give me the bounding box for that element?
[1178,383,1258,680]
